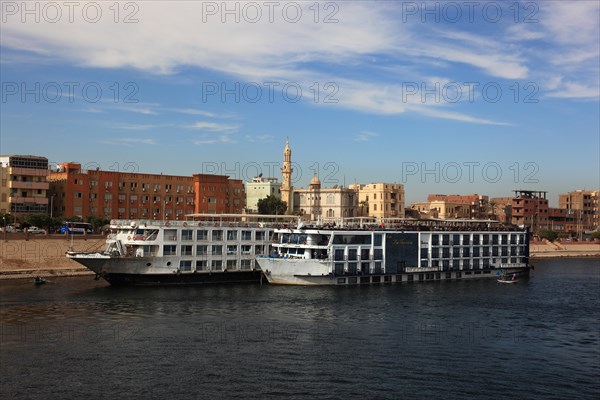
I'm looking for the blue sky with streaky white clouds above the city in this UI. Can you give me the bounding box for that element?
[0,0,600,205]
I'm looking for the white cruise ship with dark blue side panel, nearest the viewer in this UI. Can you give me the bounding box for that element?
[257,220,531,285]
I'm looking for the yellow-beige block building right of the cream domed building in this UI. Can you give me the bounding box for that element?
[349,183,404,219]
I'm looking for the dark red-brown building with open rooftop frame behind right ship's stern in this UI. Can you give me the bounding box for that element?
[512,190,549,232]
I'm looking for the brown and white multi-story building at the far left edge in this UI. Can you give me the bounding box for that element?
[0,155,49,218]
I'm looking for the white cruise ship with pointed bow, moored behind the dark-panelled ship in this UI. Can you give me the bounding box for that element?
[67,214,294,285]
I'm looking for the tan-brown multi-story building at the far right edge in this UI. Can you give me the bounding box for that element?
[558,190,600,232]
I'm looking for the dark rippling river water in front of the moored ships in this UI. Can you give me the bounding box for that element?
[0,259,600,399]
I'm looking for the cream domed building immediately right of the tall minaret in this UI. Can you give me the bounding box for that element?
[293,175,358,221]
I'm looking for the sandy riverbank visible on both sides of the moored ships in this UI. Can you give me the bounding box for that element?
[0,234,600,279]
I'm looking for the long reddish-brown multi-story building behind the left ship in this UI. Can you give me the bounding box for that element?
[48,163,245,220]
